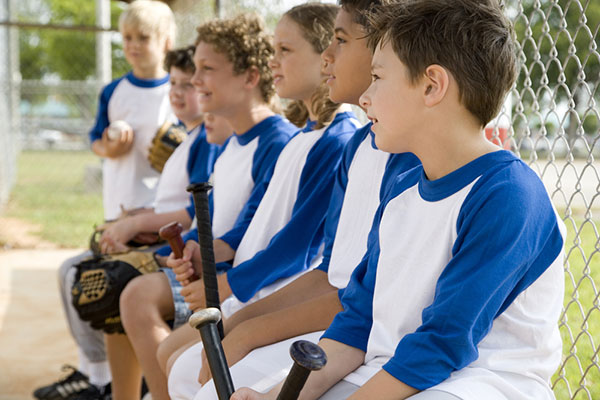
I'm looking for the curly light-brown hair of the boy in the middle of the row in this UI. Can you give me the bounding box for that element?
[196,14,275,103]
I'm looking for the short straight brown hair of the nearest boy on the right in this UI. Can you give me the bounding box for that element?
[367,0,517,126]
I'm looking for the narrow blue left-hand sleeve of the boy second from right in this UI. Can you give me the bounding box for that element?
[316,128,368,273]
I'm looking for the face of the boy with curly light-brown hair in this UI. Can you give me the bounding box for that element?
[192,42,246,115]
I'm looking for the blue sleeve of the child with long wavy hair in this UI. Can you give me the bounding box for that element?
[227,131,352,301]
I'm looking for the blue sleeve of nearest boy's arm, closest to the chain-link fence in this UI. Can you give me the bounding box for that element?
[383,166,563,390]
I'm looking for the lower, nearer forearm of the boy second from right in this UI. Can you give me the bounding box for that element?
[234,291,342,352]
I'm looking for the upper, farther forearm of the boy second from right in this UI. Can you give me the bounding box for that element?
[226,270,337,329]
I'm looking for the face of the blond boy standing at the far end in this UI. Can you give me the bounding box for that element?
[121,25,167,71]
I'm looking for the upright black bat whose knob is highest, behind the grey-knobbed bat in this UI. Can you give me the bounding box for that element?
[187,182,224,339]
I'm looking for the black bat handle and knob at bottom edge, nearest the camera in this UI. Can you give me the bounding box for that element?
[277,340,327,400]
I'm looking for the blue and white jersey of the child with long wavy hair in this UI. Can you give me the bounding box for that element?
[227,112,357,302]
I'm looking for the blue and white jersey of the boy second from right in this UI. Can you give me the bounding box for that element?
[317,123,420,289]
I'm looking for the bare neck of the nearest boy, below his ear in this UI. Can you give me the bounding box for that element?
[414,114,501,180]
